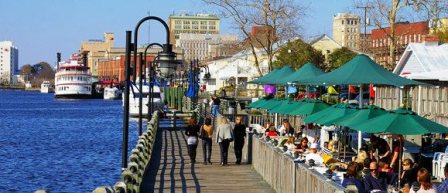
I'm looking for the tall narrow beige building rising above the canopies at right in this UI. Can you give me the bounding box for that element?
[333,13,361,50]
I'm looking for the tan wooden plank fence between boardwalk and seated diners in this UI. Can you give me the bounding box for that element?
[252,137,344,193]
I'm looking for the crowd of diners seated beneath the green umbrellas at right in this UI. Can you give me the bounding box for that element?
[258,119,448,193]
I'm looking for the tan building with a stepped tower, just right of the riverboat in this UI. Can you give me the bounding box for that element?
[80,33,114,78]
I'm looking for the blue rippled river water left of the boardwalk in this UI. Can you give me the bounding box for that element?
[0,90,138,193]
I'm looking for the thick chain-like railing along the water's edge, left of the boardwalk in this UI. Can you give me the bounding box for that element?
[93,111,159,193]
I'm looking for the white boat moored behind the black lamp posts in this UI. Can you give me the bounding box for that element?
[123,84,164,117]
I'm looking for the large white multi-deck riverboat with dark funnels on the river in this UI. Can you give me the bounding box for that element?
[54,54,92,98]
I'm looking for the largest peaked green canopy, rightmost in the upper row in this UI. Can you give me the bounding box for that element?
[299,54,425,86]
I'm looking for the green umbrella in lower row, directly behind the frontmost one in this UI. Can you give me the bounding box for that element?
[334,105,387,127]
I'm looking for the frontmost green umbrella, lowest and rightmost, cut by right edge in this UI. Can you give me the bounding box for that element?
[353,108,448,135]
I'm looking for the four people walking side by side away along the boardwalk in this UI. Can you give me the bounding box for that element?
[185,116,246,165]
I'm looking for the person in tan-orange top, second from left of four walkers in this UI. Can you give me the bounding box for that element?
[200,118,213,165]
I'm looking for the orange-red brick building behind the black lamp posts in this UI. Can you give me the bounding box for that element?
[98,55,154,83]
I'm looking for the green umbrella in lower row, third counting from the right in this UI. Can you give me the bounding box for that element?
[304,103,357,126]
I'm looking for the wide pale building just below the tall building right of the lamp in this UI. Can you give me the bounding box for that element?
[176,33,239,61]
